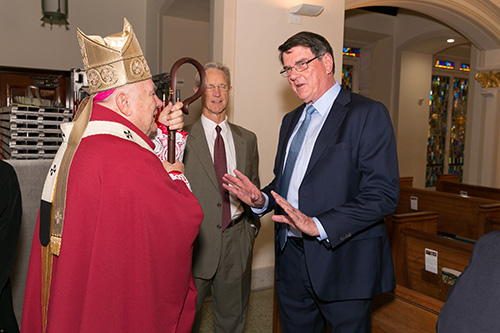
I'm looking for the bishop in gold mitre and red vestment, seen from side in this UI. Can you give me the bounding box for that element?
[21,20,203,332]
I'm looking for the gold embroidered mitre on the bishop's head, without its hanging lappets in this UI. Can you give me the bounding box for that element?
[77,18,151,94]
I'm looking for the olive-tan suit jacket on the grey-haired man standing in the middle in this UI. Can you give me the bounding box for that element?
[184,119,260,279]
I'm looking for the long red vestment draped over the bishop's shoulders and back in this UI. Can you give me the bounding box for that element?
[21,104,203,333]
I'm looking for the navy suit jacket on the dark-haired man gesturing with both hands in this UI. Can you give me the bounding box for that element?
[263,89,399,301]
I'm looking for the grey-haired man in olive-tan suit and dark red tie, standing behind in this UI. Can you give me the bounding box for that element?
[184,62,260,332]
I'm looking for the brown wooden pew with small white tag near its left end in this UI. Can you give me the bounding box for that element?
[395,187,500,240]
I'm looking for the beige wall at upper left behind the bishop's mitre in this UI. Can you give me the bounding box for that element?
[0,0,147,70]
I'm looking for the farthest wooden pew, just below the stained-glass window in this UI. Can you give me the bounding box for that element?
[436,175,500,201]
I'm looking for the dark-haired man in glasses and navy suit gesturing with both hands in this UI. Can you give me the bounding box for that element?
[224,32,399,332]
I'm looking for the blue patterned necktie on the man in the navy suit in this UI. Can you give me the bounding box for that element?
[278,104,316,250]
